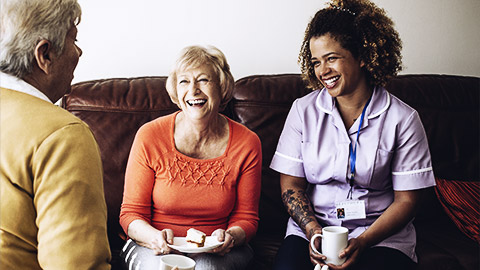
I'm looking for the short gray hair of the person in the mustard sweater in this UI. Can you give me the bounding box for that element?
[0,0,82,78]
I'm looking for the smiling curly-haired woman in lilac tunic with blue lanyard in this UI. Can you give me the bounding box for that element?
[270,0,435,270]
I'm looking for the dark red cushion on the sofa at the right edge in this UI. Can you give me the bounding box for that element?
[435,178,480,243]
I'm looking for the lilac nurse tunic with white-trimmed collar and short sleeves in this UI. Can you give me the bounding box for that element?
[270,87,435,261]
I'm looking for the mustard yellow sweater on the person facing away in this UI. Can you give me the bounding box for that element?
[0,88,110,270]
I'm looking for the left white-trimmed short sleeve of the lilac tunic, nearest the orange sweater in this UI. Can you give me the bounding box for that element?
[270,99,305,177]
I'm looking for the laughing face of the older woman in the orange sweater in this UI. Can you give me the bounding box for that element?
[176,64,221,120]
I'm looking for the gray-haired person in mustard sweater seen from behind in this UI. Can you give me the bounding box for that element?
[0,0,111,269]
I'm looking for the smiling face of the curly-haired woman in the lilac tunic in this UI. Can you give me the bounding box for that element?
[310,34,367,97]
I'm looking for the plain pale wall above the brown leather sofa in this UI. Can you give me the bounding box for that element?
[74,0,480,82]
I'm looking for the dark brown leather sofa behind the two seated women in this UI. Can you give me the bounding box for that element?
[62,74,480,270]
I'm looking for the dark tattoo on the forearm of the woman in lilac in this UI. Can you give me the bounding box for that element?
[282,189,315,232]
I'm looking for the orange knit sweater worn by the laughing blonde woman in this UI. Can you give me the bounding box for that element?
[120,112,262,241]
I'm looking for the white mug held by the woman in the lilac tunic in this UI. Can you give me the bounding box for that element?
[310,226,348,265]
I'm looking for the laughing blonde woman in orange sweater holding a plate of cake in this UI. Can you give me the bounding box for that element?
[120,46,262,269]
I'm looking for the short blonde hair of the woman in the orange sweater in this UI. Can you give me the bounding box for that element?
[166,45,234,110]
